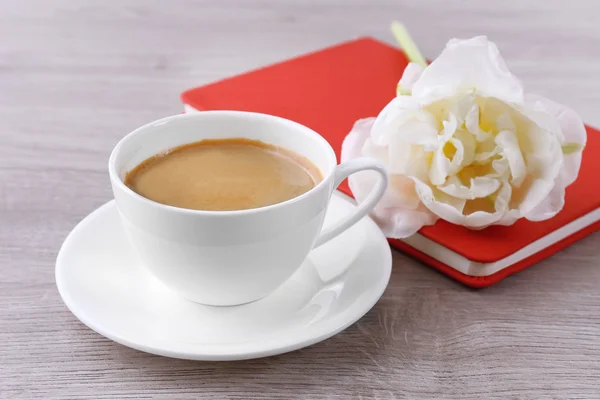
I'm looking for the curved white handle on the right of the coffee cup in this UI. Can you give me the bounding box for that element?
[313,157,388,248]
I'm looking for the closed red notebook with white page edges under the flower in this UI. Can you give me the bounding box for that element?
[181,38,600,287]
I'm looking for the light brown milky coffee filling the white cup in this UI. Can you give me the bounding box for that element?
[125,138,323,211]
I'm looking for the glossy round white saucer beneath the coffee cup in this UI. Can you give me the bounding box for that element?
[56,193,392,360]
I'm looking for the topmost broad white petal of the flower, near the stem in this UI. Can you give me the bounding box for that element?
[412,36,523,104]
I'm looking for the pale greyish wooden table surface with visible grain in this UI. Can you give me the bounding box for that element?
[0,0,600,399]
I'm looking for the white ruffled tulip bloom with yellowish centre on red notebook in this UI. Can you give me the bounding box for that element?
[342,36,586,238]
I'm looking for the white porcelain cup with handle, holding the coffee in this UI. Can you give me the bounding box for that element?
[108,111,387,306]
